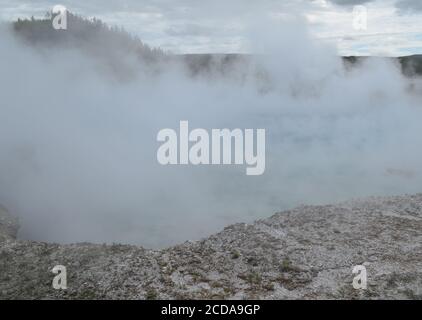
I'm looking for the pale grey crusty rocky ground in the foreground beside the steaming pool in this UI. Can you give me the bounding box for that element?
[0,194,422,299]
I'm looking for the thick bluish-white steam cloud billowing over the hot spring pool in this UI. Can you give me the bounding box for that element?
[0,18,422,247]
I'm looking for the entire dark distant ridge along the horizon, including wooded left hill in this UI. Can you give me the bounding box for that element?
[9,13,422,76]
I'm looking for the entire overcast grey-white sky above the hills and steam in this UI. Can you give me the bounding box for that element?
[0,0,422,56]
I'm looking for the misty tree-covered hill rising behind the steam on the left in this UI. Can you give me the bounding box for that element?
[13,13,165,79]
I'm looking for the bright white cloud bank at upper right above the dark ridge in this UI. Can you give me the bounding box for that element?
[308,0,422,56]
